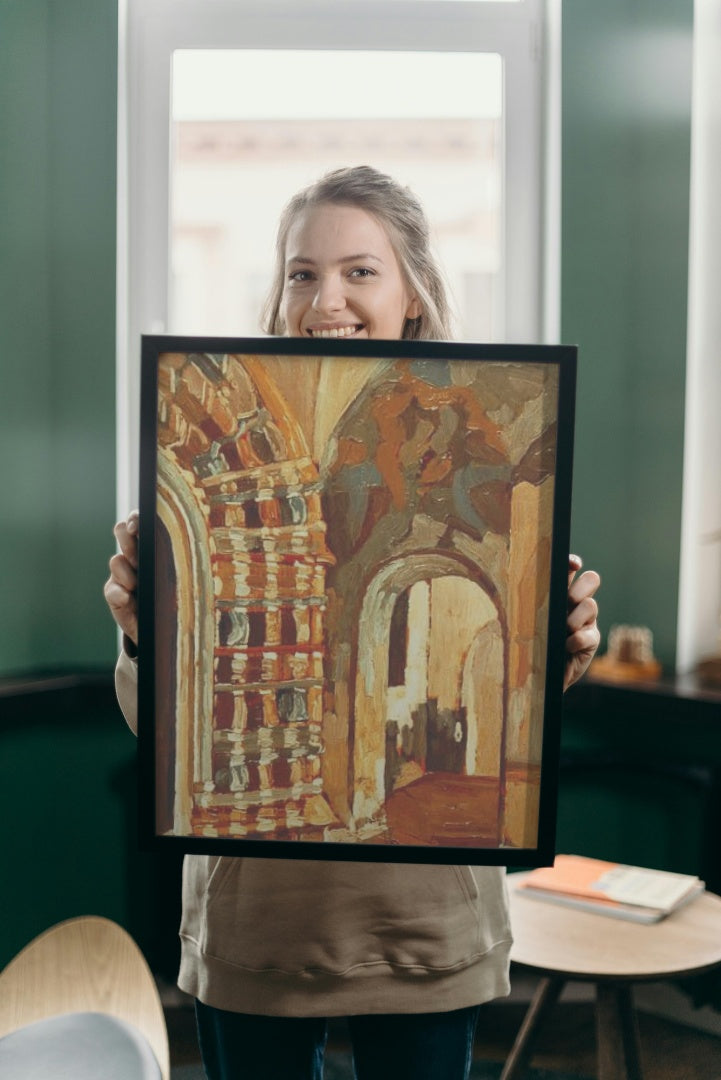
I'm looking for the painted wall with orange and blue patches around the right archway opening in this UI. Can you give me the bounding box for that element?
[321,361,556,846]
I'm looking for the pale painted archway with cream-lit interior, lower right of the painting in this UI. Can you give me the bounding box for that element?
[352,551,506,822]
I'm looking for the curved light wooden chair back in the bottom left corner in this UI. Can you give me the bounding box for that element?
[0,915,171,1080]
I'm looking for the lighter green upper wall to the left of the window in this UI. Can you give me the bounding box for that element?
[0,0,118,676]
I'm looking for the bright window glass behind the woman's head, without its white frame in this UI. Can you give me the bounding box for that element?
[168,50,503,340]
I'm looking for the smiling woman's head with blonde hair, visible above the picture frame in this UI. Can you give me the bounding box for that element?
[264,166,451,339]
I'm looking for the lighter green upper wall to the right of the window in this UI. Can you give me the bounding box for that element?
[561,0,693,667]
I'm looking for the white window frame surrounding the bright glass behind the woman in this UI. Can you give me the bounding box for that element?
[117,0,560,516]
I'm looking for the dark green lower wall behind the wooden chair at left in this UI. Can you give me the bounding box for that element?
[0,673,180,980]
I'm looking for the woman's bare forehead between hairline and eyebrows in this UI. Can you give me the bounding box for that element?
[285,203,395,260]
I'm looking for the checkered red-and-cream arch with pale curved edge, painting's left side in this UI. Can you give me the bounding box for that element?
[157,353,334,838]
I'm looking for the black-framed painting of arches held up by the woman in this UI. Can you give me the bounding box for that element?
[138,337,575,866]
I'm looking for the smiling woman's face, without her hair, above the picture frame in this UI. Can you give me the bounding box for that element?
[281,203,421,338]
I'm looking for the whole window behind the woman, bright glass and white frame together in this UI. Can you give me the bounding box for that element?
[118,0,558,514]
